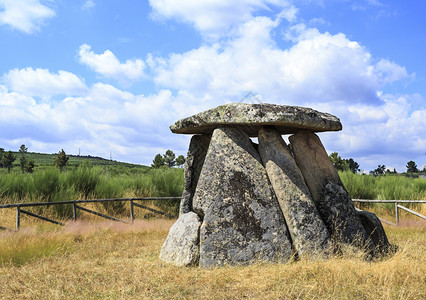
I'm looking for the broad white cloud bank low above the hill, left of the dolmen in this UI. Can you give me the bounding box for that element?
[0,83,187,164]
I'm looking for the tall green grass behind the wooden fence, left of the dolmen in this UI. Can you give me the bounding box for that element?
[0,165,184,219]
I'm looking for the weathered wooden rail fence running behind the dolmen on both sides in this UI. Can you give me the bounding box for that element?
[0,197,426,231]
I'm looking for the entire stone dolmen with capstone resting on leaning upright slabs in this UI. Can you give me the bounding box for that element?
[160,103,390,267]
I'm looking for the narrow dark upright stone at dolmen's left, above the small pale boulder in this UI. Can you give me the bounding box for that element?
[179,135,210,214]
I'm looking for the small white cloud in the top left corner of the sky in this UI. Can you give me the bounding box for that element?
[0,0,55,34]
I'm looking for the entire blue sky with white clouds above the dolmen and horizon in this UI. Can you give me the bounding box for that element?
[0,0,426,171]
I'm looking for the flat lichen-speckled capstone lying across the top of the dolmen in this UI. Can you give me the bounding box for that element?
[170,103,342,137]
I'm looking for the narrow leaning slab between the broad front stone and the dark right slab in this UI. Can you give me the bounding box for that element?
[259,126,331,256]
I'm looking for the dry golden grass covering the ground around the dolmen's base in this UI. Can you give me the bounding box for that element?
[0,213,426,299]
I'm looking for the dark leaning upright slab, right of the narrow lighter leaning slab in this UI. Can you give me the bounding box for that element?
[289,131,368,247]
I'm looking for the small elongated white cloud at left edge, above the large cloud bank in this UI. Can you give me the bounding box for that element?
[2,68,87,97]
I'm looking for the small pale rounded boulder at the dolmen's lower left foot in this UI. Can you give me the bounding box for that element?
[160,212,201,266]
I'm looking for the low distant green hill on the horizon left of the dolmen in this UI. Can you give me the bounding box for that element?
[4,151,150,168]
